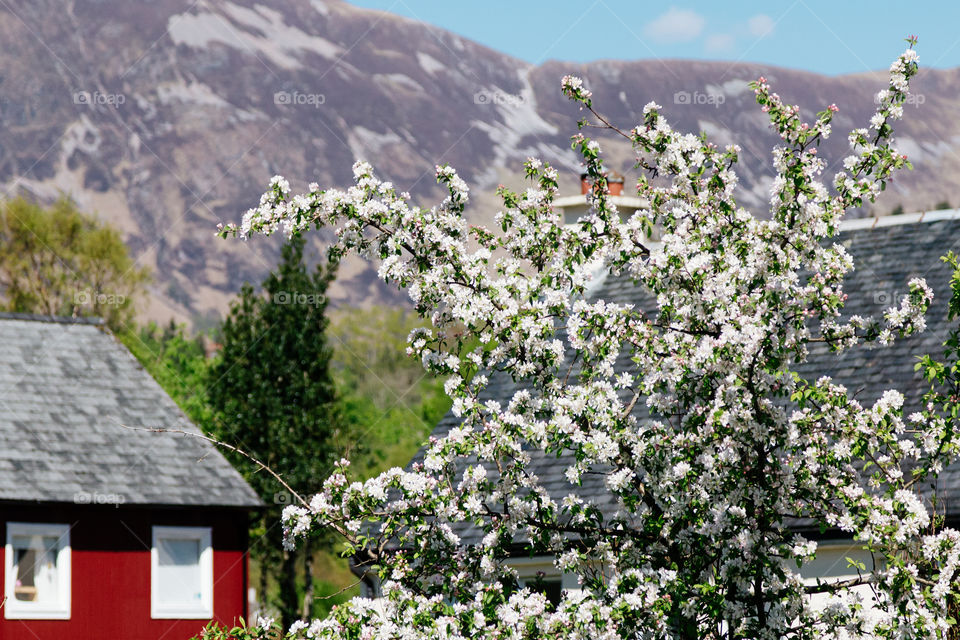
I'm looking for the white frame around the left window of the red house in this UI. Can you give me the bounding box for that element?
[3,522,72,620]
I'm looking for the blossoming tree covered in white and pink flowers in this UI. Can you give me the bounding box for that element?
[210,41,960,639]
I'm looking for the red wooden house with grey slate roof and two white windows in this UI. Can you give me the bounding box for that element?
[0,314,260,640]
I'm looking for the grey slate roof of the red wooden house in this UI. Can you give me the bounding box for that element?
[0,314,261,507]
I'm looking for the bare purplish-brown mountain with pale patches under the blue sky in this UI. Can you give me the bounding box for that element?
[0,0,960,323]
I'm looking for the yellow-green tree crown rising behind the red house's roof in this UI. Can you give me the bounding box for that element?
[0,198,149,331]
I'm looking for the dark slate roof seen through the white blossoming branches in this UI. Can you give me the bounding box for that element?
[413,211,960,545]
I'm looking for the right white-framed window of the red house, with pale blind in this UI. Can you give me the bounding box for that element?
[150,527,213,619]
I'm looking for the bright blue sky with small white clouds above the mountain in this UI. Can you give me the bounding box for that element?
[350,0,960,75]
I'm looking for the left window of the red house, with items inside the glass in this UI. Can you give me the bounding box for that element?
[3,522,70,620]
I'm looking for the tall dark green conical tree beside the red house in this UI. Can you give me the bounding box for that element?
[206,239,344,625]
